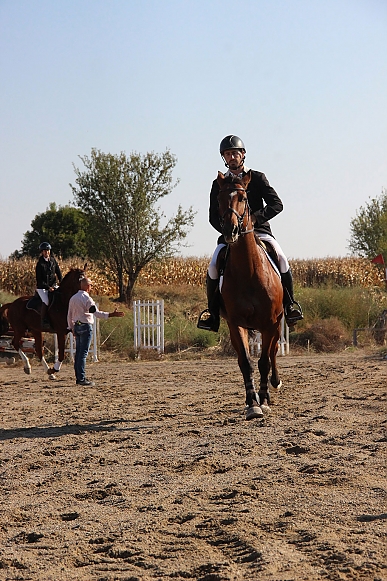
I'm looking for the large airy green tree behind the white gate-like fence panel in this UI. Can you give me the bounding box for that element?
[70,149,194,304]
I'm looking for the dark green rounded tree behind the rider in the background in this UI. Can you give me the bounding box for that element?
[17,202,87,258]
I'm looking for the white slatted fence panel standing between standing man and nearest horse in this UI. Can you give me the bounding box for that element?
[133,299,164,353]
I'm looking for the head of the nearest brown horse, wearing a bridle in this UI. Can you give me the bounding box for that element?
[217,171,253,244]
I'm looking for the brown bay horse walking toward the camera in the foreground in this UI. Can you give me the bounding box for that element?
[218,172,283,420]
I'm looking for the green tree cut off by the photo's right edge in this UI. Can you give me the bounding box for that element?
[349,189,387,263]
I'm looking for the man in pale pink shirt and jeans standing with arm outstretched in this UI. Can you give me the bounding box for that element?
[67,277,125,387]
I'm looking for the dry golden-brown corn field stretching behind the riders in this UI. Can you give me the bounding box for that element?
[0,257,385,296]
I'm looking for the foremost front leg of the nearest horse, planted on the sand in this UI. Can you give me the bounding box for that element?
[228,323,263,420]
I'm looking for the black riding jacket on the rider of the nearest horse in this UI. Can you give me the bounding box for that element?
[210,170,283,244]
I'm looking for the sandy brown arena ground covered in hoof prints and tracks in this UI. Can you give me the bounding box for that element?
[0,354,387,581]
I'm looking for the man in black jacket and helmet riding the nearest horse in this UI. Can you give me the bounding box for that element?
[198,135,303,332]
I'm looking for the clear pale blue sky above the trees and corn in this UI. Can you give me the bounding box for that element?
[0,0,387,259]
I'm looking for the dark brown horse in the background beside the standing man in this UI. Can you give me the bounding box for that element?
[0,265,86,379]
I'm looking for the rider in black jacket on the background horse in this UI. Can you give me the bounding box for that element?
[35,242,62,331]
